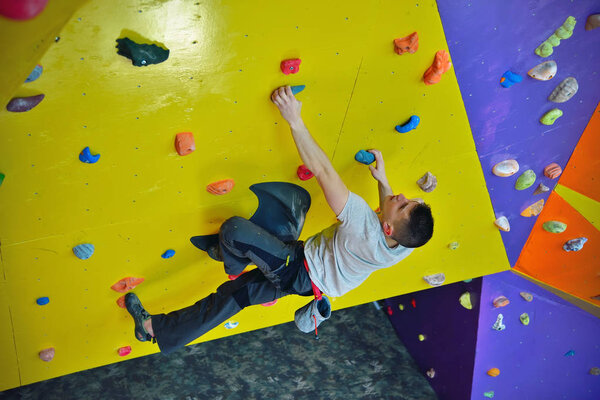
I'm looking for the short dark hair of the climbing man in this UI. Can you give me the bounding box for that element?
[392,204,433,248]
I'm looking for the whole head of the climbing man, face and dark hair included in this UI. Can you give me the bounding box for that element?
[381,194,433,247]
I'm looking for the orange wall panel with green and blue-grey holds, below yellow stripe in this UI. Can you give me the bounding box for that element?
[514,192,600,307]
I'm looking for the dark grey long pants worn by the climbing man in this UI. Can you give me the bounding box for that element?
[152,217,312,354]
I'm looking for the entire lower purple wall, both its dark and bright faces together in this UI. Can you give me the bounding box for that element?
[385,271,600,400]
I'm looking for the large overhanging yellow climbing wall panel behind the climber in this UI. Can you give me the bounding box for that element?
[0,0,509,390]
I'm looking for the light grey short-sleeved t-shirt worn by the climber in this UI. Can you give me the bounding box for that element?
[304,192,413,297]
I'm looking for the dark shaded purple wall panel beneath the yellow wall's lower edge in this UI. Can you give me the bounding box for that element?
[385,278,482,400]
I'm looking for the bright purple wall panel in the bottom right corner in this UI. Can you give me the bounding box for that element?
[474,271,600,400]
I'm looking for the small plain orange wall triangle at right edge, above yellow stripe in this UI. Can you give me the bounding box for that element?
[559,103,600,201]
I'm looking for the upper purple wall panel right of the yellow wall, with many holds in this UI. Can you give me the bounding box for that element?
[438,0,600,265]
